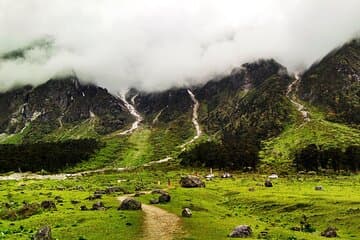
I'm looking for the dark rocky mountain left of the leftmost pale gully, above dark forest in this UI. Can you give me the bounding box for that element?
[0,76,134,142]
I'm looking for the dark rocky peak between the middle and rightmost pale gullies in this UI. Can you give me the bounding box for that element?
[195,59,291,138]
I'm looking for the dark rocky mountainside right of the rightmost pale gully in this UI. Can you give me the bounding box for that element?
[298,39,360,125]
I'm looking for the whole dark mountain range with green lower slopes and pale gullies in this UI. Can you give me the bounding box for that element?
[0,40,360,172]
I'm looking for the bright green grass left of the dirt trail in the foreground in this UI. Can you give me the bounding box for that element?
[0,177,142,240]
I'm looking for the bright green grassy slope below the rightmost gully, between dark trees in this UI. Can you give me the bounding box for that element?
[259,99,360,171]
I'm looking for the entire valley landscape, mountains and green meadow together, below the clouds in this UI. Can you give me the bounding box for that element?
[0,39,360,240]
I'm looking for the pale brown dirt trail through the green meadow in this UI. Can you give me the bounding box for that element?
[118,195,184,240]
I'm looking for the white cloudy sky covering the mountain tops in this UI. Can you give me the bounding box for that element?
[0,0,360,92]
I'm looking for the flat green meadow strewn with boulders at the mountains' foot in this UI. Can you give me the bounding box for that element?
[0,162,360,240]
